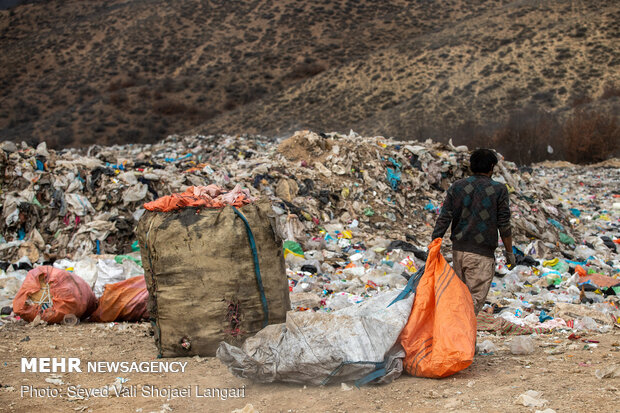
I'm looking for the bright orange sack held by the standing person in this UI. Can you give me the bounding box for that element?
[399,238,476,378]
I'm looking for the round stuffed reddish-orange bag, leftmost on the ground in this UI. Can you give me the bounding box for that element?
[13,265,97,324]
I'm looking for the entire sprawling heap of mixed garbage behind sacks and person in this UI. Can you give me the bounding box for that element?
[0,131,620,329]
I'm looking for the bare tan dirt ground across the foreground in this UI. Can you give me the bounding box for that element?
[0,323,620,413]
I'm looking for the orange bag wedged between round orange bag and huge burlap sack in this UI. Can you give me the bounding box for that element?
[90,275,149,322]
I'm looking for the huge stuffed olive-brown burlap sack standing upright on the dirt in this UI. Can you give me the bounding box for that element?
[137,202,290,357]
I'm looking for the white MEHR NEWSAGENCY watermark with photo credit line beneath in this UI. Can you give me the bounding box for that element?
[20,357,245,400]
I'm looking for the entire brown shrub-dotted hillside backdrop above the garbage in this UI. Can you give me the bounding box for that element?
[0,0,620,156]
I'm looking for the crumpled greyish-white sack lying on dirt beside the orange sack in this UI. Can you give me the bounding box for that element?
[217,291,413,385]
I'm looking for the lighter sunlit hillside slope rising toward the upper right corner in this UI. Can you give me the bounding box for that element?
[197,2,620,139]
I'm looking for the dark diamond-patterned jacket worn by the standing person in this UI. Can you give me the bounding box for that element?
[432,175,511,257]
